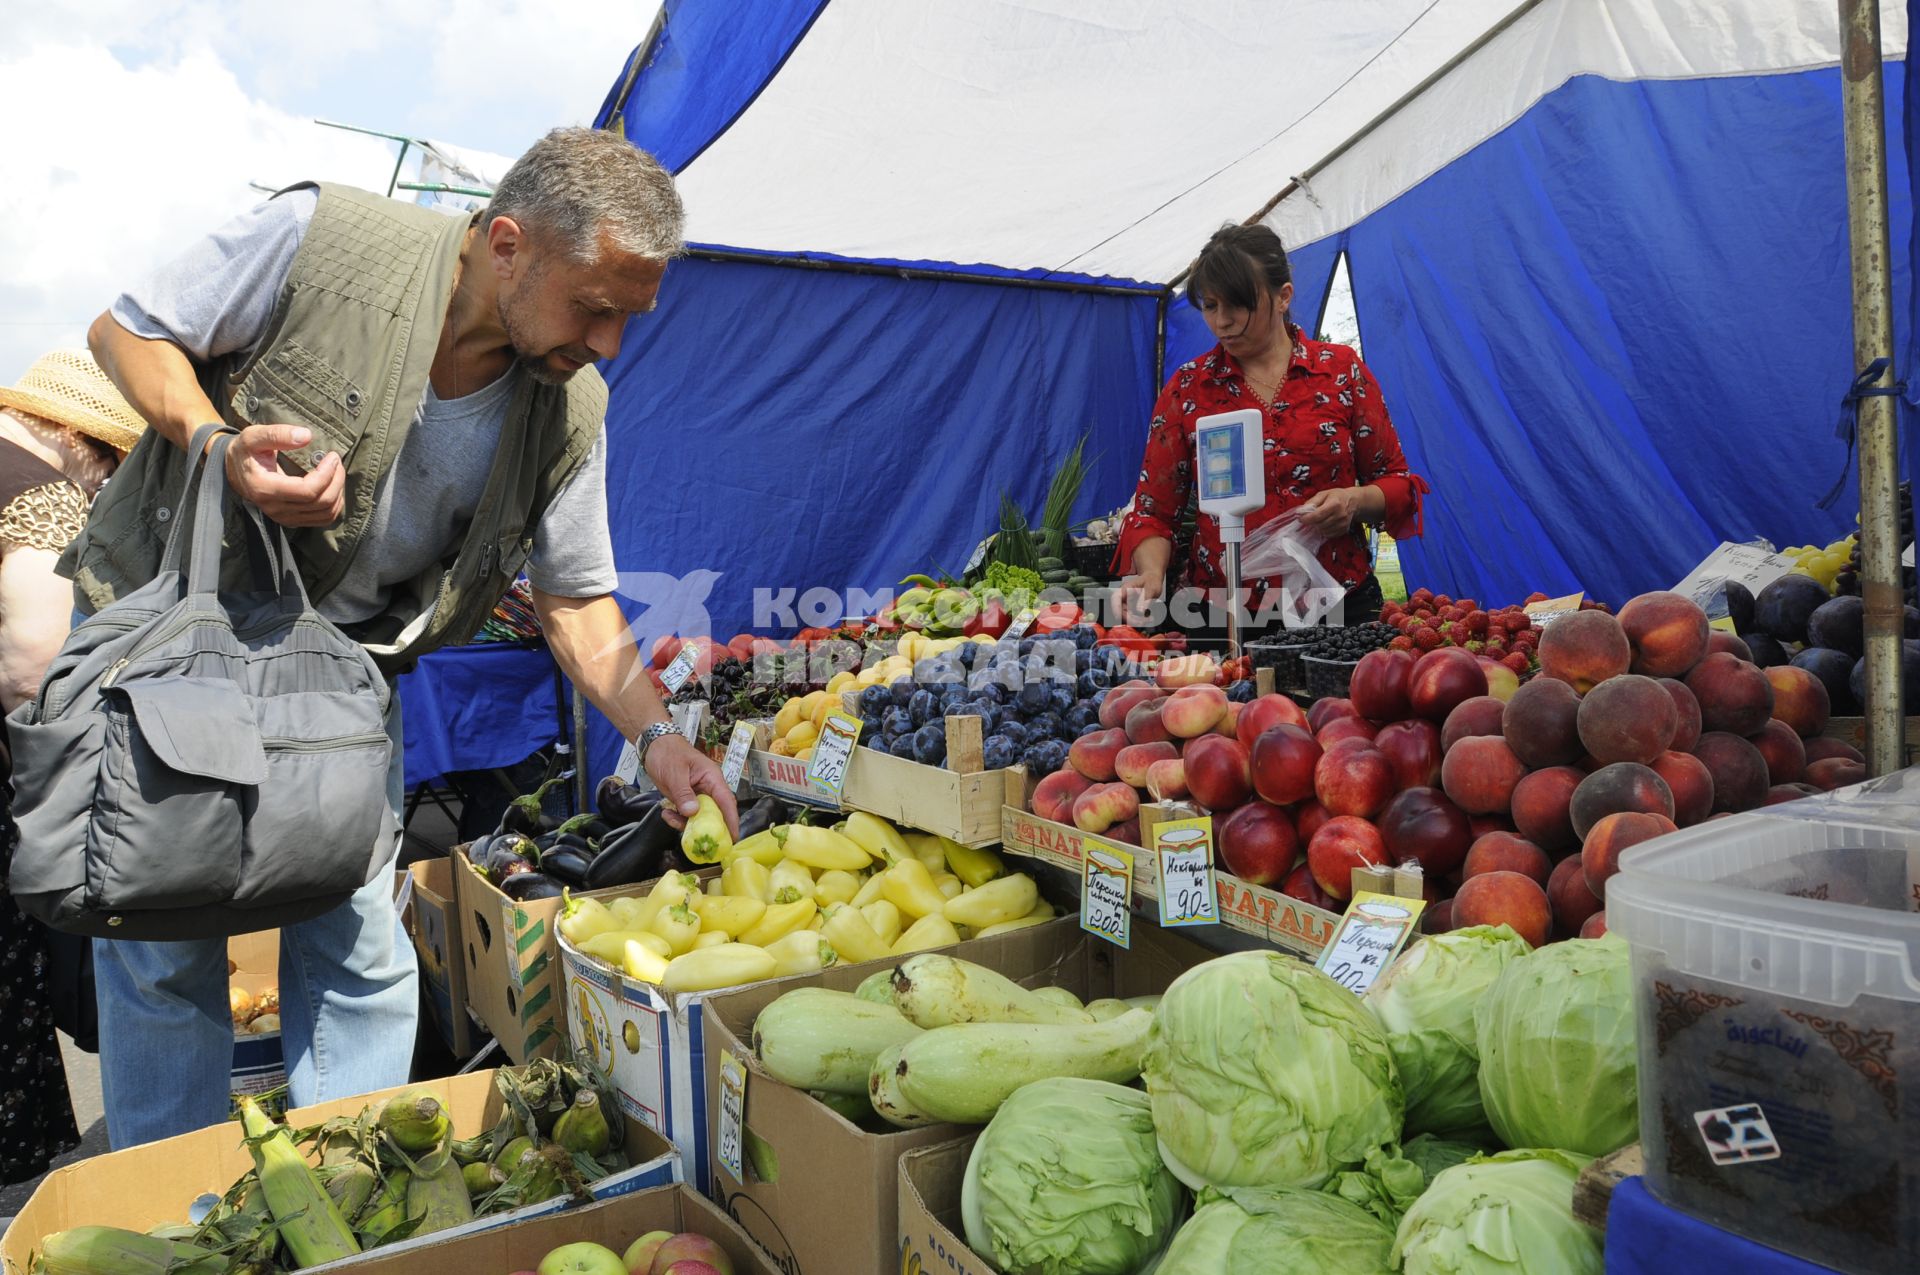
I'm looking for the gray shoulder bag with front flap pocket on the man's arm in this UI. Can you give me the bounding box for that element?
[8,424,394,939]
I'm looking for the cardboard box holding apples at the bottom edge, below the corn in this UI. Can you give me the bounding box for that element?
[355,1187,771,1275]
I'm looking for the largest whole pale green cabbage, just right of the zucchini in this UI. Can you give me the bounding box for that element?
[1142,952,1402,1191]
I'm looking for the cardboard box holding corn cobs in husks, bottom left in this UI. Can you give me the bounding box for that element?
[0,1071,680,1275]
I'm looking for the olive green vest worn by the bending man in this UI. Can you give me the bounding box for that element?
[60,184,607,674]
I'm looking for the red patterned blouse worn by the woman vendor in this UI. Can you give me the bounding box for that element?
[1114,325,1428,588]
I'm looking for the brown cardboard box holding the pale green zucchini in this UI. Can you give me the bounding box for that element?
[705,918,1213,1275]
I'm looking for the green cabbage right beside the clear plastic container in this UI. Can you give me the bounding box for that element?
[1475,935,1640,1156]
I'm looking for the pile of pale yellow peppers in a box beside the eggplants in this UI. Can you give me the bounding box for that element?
[559,812,1054,993]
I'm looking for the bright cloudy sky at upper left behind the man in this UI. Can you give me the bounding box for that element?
[0,0,659,384]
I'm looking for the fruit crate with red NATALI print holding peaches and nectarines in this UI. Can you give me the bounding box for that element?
[1000,805,1340,960]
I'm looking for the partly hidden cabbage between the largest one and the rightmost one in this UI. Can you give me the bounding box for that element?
[1365,926,1532,1137]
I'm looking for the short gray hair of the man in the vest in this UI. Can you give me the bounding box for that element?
[486,129,685,265]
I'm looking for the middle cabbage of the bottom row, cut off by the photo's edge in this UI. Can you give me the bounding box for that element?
[1154,1182,1394,1275]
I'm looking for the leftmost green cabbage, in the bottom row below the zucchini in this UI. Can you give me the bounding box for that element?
[960,1079,1183,1275]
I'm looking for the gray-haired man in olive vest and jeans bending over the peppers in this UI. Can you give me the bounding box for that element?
[76,129,733,1146]
